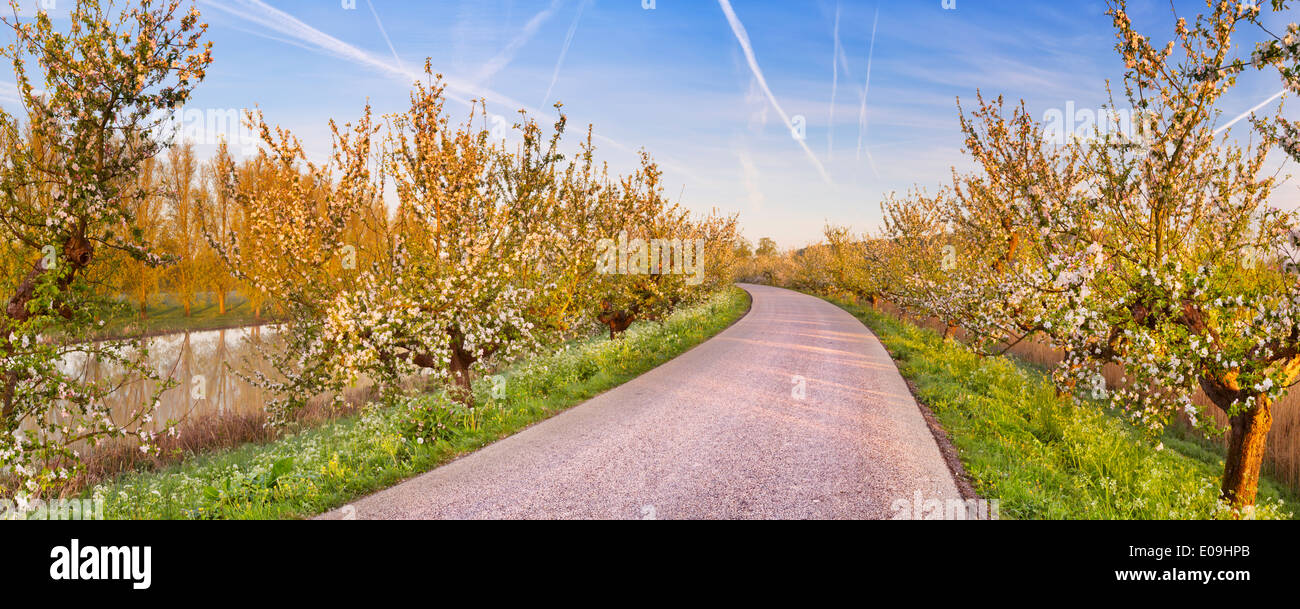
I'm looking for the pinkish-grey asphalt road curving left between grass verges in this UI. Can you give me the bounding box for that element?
[321,285,959,519]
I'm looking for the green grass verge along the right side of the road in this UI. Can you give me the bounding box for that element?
[840,303,1295,519]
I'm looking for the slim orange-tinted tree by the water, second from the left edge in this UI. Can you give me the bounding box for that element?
[205,108,377,423]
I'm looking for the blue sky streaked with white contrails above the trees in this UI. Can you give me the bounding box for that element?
[0,0,1296,246]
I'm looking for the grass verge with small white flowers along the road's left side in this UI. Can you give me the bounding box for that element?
[90,288,749,519]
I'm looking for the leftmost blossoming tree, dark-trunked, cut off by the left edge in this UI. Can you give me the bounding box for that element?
[0,0,212,501]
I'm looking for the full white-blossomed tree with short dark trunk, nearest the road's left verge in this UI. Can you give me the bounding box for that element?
[340,64,564,403]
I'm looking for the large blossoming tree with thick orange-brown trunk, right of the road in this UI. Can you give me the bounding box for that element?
[873,1,1300,513]
